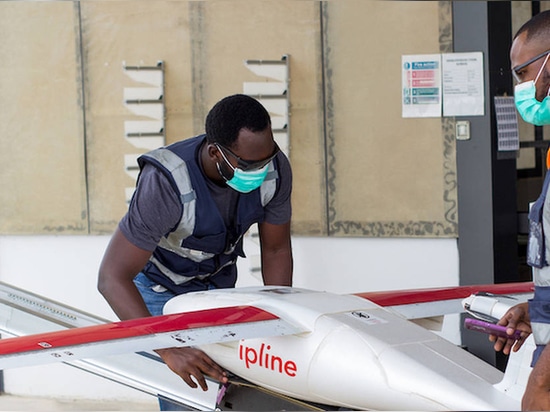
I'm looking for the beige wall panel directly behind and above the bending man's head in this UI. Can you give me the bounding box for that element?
[185,0,325,234]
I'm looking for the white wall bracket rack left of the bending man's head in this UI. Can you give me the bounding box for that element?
[122,60,166,203]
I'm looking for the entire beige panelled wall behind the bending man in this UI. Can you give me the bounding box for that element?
[0,0,457,237]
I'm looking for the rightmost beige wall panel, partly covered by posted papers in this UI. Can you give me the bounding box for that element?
[325,1,457,237]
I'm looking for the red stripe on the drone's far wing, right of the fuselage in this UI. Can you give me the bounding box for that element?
[356,282,534,306]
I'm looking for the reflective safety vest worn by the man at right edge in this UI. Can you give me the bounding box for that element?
[527,167,550,365]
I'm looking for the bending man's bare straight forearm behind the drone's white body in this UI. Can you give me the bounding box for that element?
[258,221,293,286]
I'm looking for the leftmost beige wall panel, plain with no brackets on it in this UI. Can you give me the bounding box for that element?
[0,2,88,234]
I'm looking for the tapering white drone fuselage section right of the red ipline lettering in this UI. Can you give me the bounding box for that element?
[308,310,503,411]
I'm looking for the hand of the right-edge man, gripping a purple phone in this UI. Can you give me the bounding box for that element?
[489,302,531,355]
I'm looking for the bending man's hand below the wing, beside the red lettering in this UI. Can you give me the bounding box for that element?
[155,348,227,391]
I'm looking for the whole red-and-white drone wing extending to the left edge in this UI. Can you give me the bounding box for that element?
[0,306,299,369]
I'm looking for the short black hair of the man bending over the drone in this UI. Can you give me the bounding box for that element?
[205,94,271,148]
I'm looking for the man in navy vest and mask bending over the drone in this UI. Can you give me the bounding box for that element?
[98,95,292,409]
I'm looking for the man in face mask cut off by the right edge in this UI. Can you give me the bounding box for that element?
[490,11,550,410]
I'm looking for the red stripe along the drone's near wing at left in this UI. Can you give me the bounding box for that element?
[0,306,278,355]
